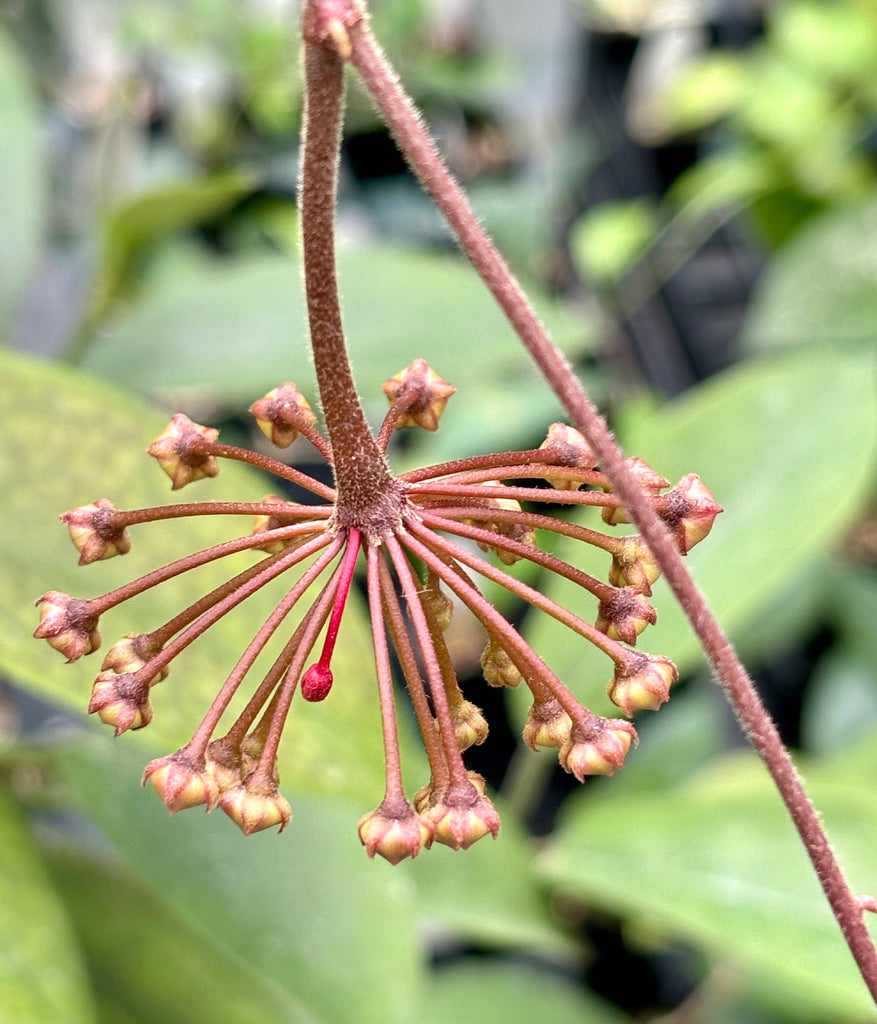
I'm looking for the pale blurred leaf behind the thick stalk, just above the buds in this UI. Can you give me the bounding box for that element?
[85,247,581,403]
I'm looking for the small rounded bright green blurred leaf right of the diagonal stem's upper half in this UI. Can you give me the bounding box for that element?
[572,199,658,285]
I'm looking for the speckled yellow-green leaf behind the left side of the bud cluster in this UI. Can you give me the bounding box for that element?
[0,353,391,806]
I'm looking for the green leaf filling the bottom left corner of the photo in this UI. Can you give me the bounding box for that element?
[0,790,95,1024]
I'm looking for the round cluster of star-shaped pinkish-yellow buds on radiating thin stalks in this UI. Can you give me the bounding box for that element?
[35,359,721,863]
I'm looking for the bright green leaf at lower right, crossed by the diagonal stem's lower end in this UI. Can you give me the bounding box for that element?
[541,749,877,1024]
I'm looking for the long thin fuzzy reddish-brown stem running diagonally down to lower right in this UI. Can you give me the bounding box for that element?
[349,8,877,1002]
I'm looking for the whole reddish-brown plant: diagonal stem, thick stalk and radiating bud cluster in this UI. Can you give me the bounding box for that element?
[30,0,877,999]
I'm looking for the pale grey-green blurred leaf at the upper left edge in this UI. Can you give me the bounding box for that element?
[0,28,43,327]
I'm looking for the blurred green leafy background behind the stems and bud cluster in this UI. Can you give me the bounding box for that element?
[0,0,877,1024]
